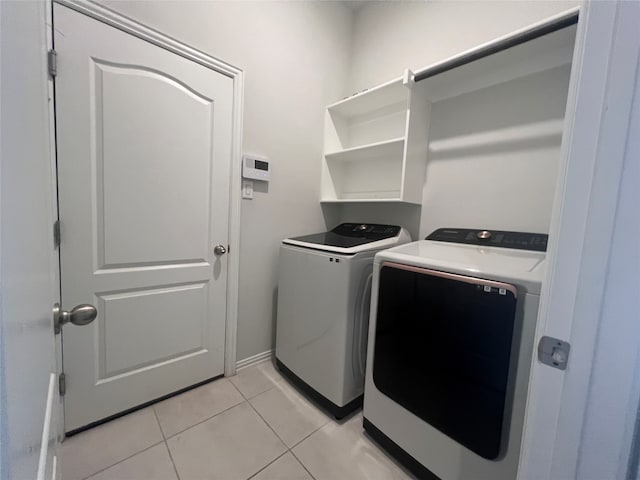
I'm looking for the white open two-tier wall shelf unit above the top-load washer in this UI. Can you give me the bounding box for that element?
[321,71,428,204]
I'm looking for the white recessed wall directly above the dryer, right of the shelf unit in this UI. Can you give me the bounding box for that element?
[420,66,571,238]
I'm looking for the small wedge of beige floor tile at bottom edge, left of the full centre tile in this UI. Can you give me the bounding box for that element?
[87,443,178,480]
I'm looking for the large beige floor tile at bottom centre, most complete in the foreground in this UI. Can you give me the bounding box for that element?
[167,402,286,480]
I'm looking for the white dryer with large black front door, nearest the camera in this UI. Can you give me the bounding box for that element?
[363,228,547,480]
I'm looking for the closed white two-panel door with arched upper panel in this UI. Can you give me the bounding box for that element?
[54,4,233,431]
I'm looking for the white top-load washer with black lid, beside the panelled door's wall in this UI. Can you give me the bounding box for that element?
[276,223,411,418]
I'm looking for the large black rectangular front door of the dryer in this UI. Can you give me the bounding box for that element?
[373,262,519,460]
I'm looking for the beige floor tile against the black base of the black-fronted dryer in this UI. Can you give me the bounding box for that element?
[293,414,412,480]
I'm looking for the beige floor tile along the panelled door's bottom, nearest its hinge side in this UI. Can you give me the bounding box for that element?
[62,408,163,480]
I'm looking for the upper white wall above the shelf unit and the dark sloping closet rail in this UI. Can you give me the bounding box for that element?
[349,0,581,92]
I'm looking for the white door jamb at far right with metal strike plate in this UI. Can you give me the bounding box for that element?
[518,2,637,480]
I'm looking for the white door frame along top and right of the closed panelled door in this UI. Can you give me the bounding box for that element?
[50,0,244,377]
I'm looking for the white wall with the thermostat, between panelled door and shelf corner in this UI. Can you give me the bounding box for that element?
[96,1,352,360]
